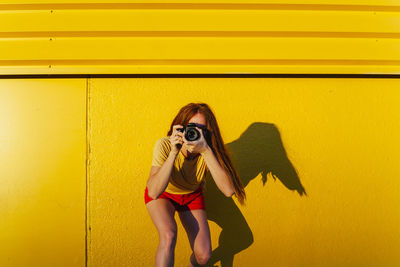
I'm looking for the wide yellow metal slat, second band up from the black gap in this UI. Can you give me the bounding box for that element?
[0,37,400,59]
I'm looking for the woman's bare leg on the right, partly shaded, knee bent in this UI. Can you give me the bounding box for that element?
[179,209,212,267]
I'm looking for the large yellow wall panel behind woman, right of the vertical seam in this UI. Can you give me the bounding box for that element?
[88,78,400,267]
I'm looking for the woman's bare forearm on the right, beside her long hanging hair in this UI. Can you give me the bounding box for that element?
[201,146,235,197]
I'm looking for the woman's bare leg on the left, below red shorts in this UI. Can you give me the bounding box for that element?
[146,198,178,267]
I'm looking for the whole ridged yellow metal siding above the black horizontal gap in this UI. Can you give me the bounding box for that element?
[0,0,400,75]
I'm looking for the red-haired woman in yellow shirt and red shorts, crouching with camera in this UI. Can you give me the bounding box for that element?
[145,103,246,267]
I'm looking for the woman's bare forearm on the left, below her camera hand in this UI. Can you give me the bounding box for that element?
[147,151,178,199]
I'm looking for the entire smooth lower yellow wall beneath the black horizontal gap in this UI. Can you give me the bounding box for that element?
[0,78,400,267]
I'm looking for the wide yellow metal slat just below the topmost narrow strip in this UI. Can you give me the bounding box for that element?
[0,9,400,34]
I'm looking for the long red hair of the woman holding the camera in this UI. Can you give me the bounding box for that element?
[167,103,246,205]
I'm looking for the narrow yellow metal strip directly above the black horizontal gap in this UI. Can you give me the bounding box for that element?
[0,61,400,75]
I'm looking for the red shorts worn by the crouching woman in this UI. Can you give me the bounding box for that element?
[144,185,206,211]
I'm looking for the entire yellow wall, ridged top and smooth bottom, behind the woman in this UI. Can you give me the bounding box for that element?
[0,0,400,267]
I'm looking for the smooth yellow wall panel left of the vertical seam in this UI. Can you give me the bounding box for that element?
[0,79,86,267]
